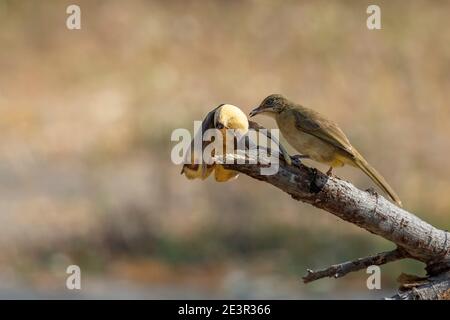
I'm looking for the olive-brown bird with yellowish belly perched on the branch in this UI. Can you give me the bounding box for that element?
[249,94,402,207]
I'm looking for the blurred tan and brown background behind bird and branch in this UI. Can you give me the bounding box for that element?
[0,0,450,299]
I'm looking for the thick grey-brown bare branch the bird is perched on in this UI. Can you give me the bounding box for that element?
[215,150,450,296]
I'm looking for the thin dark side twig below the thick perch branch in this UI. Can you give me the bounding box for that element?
[302,249,407,283]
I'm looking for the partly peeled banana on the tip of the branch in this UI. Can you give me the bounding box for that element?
[181,104,291,182]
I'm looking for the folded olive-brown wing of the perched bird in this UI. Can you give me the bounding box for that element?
[292,108,355,157]
